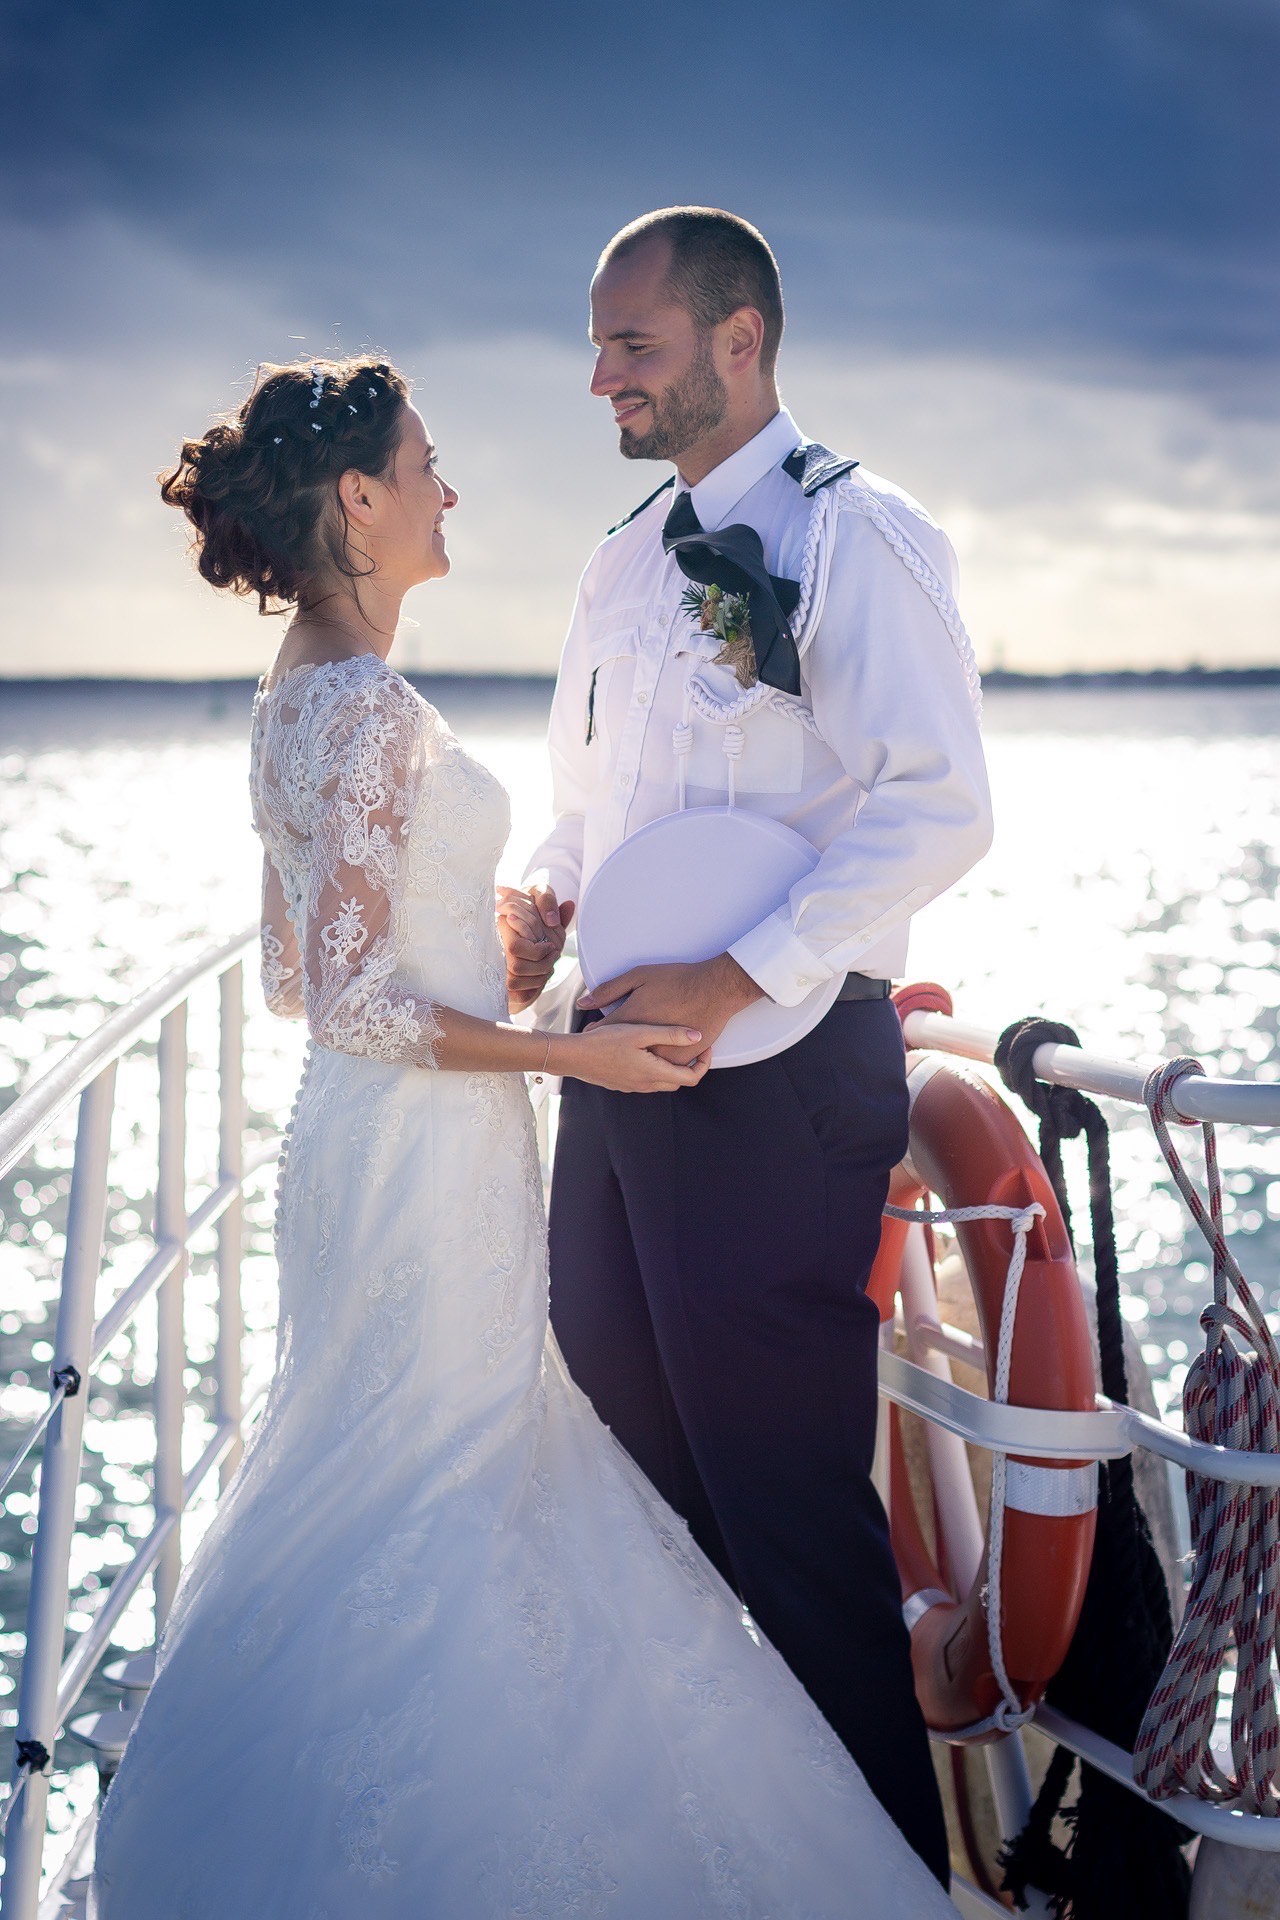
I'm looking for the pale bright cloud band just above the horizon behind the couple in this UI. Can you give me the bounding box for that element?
[0,217,1280,678]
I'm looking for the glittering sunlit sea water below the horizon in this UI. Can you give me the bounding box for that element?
[0,680,1280,1826]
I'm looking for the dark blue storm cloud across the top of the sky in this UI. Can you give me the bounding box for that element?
[0,0,1280,374]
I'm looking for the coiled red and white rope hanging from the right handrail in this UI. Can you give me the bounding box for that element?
[1134,1060,1280,1816]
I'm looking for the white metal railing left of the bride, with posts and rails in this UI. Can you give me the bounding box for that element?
[0,927,278,1920]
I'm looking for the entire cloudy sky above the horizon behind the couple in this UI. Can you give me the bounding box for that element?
[0,0,1280,678]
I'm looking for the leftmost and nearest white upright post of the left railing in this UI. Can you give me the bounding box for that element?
[0,1064,115,1920]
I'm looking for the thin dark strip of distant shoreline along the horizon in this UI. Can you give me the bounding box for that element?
[0,664,1280,699]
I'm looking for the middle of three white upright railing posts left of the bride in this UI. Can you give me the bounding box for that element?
[155,1000,188,1645]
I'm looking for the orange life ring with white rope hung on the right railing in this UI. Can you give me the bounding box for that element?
[869,987,1096,1741]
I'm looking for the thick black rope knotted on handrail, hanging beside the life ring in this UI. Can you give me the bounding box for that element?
[996,1018,1190,1920]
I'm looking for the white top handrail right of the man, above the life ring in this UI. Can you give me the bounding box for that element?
[902,1010,1280,1127]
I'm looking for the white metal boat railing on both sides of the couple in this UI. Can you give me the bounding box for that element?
[0,960,1280,1920]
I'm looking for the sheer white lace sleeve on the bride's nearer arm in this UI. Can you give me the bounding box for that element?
[303,672,439,1068]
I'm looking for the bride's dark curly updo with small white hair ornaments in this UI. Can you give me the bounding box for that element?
[159,359,409,612]
